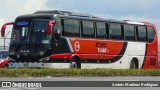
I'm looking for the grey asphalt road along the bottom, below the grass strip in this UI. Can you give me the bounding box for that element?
[0,76,160,90]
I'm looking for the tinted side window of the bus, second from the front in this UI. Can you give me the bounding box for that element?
[82,21,95,38]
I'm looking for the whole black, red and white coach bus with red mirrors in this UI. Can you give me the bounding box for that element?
[1,10,158,69]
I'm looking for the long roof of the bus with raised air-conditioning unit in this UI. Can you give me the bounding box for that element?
[16,10,153,25]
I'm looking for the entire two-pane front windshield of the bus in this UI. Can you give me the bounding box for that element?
[11,19,49,44]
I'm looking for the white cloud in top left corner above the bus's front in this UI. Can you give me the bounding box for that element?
[0,0,47,21]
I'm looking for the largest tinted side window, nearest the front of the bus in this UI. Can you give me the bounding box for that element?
[62,19,80,37]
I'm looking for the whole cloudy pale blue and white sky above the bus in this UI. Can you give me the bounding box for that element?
[0,0,160,39]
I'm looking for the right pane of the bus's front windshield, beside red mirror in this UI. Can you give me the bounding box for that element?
[29,19,49,44]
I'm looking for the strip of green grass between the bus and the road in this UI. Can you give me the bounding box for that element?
[0,68,160,77]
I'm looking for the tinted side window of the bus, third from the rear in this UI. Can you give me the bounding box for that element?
[124,25,136,41]
